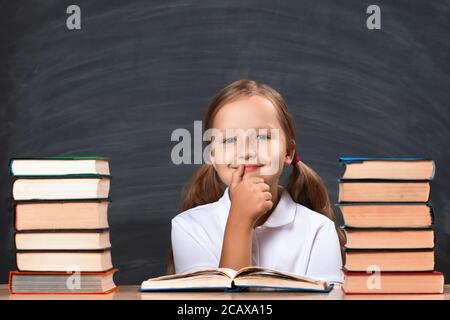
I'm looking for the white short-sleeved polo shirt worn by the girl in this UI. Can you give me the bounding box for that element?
[171,187,344,283]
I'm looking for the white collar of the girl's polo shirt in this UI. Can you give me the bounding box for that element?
[219,187,297,228]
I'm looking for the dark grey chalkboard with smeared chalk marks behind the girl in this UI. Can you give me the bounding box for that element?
[0,0,450,284]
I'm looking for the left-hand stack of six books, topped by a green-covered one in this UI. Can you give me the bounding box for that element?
[9,157,117,294]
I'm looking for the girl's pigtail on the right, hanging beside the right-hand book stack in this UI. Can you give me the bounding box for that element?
[286,161,346,261]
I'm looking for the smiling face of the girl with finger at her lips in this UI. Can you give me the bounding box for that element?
[211,95,295,186]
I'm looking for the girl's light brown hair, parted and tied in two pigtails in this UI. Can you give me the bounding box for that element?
[167,79,345,274]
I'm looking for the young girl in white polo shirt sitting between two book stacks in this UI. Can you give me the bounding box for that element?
[168,80,345,282]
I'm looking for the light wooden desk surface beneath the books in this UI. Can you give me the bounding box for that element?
[0,284,450,300]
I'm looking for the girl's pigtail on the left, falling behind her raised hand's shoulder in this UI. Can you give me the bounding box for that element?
[167,164,225,274]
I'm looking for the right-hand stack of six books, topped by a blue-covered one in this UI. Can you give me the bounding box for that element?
[337,158,444,294]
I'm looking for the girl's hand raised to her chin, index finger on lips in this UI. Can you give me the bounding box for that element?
[230,164,273,227]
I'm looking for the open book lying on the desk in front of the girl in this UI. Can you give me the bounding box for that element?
[141,267,333,292]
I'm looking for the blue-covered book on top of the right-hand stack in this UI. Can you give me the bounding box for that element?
[339,157,435,181]
